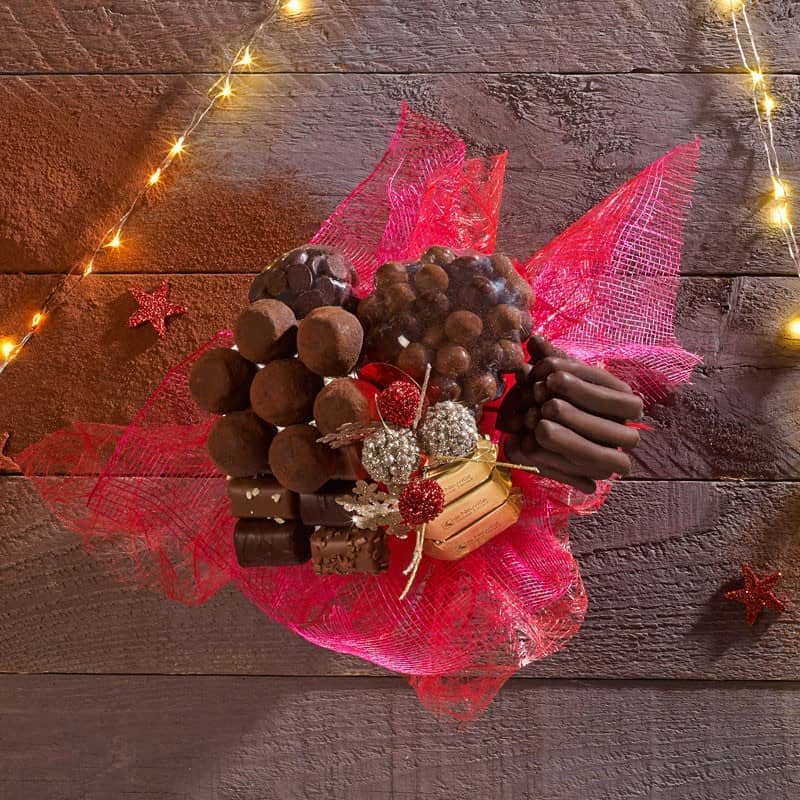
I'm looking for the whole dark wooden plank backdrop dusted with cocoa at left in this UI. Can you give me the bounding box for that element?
[0,0,800,800]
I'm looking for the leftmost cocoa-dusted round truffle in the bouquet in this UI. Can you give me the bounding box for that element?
[189,347,256,414]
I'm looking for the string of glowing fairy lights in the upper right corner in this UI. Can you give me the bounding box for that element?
[725,0,800,282]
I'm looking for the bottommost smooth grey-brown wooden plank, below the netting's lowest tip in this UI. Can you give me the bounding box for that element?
[0,676,800,800]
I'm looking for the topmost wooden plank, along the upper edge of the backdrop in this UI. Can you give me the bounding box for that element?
[0,0,800,73]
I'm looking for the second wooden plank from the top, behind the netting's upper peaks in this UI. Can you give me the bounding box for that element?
[0,74,800,275]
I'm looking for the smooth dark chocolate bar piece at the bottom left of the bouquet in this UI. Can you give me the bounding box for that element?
[233,519,312,567]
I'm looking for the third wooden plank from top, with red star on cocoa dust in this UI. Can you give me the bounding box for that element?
[6,275,800,479]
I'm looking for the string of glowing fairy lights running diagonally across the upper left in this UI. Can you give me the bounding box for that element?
[0,0,304,374]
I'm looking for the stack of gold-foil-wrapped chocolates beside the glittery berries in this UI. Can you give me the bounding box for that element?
[424,450,520,561]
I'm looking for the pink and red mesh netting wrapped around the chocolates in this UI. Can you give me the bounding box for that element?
[19,107,698,721]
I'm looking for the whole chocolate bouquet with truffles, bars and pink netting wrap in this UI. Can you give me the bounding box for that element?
[19,107,698,720]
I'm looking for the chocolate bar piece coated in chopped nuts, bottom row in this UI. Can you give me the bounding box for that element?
[311,527,389,575]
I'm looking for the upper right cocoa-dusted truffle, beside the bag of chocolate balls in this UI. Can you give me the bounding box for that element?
[297,306,364,378]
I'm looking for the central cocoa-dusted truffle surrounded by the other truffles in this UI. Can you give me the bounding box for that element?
[250,360,324,426]
